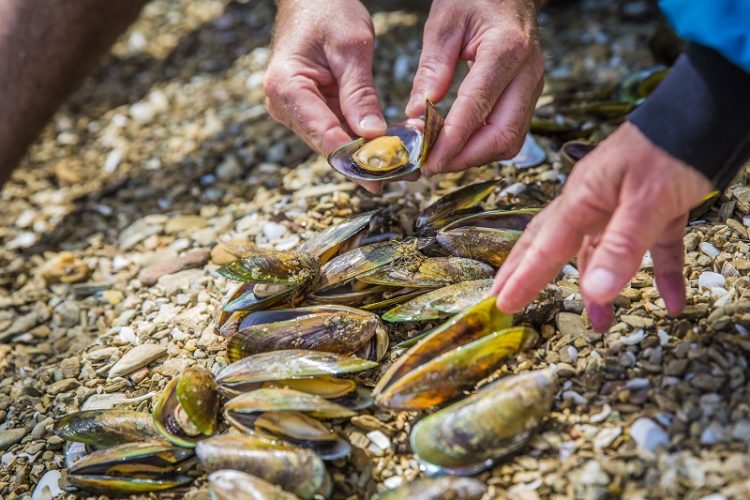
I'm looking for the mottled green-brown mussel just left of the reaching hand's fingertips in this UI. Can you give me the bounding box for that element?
[382,279,492,323]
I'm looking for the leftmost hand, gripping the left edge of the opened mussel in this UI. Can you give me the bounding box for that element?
[264,0,386,192]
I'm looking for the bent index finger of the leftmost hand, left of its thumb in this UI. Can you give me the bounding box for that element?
[265,75,351,155]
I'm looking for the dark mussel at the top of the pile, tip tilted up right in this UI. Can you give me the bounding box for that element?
[416,179,500,236]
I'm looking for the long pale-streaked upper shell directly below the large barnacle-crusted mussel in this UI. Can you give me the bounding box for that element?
[216,349,378,390]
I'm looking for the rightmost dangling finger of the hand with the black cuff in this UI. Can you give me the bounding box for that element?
[651,216,687,316]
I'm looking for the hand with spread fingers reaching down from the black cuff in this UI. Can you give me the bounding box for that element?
[492,122,712,331]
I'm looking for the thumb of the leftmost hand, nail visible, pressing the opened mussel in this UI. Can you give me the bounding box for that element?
[329,38,386,139]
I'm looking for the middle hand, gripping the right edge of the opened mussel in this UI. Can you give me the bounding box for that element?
[406,0,544,175]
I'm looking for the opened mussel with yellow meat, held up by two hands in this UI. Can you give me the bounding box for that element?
[328,100,443,181]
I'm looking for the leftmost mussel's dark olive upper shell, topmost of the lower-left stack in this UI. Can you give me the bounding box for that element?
[52,409,162,447]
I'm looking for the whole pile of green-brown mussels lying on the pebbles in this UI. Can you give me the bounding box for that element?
[55,180,557,499]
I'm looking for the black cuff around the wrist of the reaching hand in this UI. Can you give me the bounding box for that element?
[628,43,750,189]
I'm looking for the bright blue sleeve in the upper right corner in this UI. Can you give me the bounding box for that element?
[659,0,750,73]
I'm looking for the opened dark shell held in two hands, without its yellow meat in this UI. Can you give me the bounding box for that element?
[328,100,443,181]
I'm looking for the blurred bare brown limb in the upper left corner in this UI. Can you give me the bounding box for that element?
[0,0,145,185]
